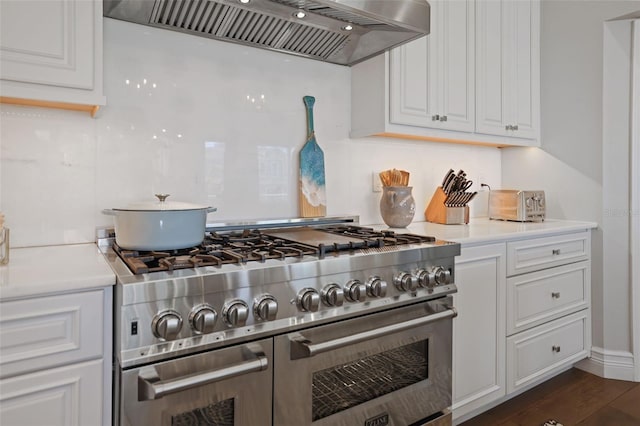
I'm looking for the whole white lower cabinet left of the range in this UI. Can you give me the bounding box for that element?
[0,287,112,426]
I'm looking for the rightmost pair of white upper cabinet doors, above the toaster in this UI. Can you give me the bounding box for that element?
[476,0,540,139]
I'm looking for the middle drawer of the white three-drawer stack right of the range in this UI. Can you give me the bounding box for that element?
[507,261,591,335]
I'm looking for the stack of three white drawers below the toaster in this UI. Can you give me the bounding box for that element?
[507,231,591,393]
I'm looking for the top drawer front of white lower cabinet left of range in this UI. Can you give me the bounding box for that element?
[0,290,104,378]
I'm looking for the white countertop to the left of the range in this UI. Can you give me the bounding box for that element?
[0,244,116,301]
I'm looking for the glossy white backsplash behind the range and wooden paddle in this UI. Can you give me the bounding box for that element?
[0,18,501,247]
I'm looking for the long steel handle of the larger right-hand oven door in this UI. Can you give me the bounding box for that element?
[290,307,458,360]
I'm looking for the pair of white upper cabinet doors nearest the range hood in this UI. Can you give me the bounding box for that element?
[389,0,475,132]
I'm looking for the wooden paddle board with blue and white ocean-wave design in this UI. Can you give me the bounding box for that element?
[300,96,327,217]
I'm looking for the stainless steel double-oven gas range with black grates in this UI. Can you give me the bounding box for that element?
[98,217,460,426]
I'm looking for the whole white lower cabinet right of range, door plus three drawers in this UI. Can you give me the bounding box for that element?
[452,231,591,424]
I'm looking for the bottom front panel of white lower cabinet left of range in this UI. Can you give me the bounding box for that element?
[0,360,102,426]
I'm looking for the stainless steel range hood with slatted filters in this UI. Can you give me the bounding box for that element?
[104,0,430,65]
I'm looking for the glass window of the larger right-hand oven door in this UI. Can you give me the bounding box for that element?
[311,340,429,421]
